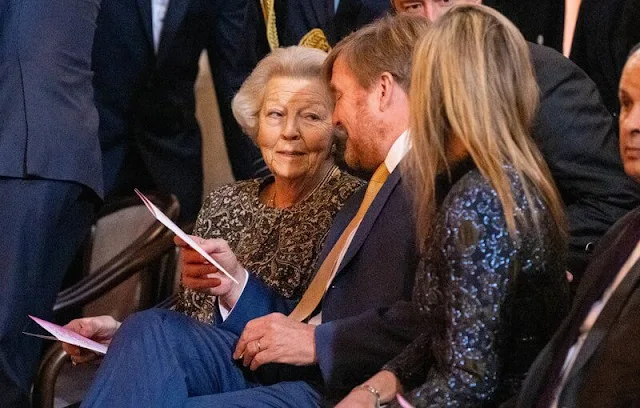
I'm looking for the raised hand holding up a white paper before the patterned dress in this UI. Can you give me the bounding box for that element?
[173,235,246,309]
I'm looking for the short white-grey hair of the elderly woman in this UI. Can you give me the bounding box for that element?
[231,46,333,142]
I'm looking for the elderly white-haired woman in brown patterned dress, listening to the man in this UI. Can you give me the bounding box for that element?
[64,47,363,363]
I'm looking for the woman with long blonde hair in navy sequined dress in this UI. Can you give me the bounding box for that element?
[339,6,568,408]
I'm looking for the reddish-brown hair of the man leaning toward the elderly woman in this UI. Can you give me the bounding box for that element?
[324,14,430,92]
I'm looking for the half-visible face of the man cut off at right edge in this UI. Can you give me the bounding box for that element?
[620,52,640,183]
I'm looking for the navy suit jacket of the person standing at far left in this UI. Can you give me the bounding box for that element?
[0,1,102,198]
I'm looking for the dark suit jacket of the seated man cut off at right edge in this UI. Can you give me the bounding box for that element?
[517,208,640,408]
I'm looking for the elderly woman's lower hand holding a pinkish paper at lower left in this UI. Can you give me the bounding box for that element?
[62,316,120,364]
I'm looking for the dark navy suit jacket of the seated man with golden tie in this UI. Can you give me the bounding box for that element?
[220,169,422,400]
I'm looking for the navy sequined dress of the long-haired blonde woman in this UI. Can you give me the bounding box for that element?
[383,161,569,407]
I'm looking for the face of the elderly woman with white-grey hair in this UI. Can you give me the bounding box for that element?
[257,77,333,180]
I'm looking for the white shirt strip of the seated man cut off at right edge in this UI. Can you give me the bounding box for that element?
[551,237,640,408]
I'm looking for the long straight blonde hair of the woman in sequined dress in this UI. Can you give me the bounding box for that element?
[407,5,565,249]
